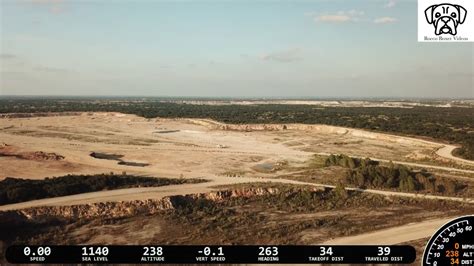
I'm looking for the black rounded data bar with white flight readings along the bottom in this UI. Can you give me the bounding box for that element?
[6,245,416,264]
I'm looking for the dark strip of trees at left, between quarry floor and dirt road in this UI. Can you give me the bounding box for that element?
[0,174,205,205]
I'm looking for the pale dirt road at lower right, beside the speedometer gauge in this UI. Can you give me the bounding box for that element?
[321,217,455,245]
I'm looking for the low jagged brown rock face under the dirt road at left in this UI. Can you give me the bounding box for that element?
[0,188,279,224]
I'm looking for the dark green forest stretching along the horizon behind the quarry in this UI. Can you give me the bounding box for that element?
[0,98,474,160]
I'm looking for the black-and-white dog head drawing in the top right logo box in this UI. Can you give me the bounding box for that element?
[425,4,467,35]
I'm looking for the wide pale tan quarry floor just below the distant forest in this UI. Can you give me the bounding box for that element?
[0,113,468,182]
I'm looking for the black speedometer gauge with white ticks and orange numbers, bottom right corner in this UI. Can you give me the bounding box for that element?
[423,215,474,266]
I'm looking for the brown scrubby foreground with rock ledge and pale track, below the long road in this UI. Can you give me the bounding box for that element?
[6,183,474,245]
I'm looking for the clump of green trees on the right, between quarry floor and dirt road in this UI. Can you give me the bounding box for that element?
[325,155,466,195]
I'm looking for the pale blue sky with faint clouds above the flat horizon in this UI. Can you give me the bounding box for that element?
[0,0,474,98]
